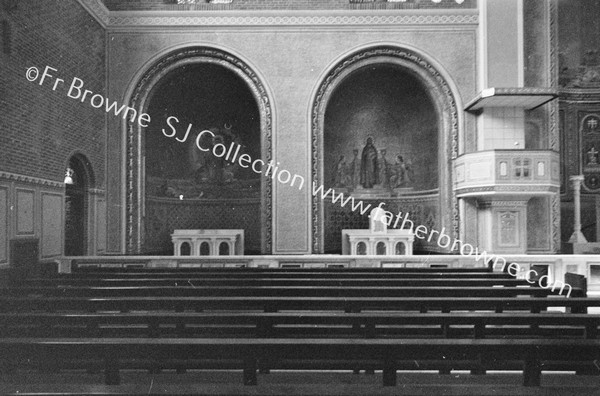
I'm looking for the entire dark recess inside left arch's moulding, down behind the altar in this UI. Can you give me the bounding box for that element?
[143,63,261,254]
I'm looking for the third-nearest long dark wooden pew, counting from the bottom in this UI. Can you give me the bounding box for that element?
[0,296,600,313]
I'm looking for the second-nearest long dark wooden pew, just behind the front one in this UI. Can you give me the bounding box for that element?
[0,311,600,339]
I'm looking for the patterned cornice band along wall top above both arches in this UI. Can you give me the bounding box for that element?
[78,0,479,29]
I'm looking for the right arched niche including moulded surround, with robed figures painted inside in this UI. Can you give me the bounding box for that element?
[311,45,459,253]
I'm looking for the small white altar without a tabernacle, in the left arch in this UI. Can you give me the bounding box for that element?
[171,230,244,256]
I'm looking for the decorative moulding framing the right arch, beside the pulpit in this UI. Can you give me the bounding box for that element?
[311,45,461,253]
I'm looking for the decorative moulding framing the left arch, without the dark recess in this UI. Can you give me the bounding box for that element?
[123,46,273,254]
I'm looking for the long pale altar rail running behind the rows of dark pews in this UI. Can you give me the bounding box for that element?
[56,255,600,294]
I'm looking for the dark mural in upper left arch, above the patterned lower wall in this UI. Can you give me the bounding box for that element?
[146,63,261,199]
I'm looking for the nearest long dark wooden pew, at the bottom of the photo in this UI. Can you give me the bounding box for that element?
[0,338,600,386]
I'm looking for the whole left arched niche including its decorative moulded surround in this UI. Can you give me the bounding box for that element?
[125,47,272,254]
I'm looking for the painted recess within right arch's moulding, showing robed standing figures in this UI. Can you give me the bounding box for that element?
[324,64,439,253]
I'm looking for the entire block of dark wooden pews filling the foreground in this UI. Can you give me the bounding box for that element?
[0,262,600,386]
